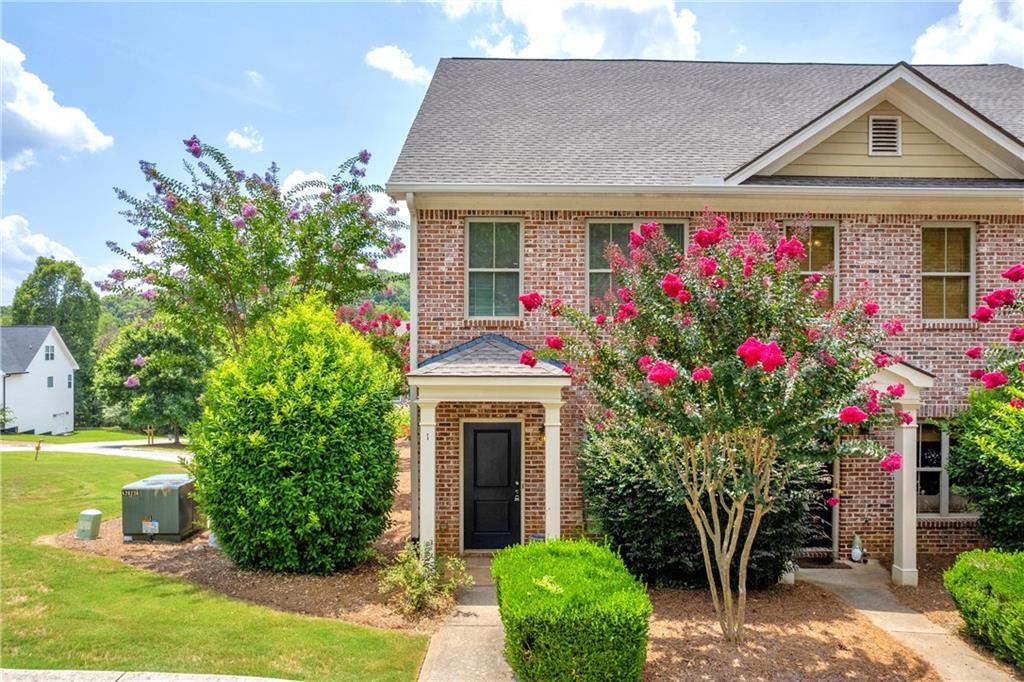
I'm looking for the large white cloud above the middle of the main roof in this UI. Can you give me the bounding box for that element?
[466,0,700,59]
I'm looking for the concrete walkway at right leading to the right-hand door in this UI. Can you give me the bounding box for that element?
[797,561,1014,682]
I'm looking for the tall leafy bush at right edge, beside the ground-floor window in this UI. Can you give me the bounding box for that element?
[949,388,1024,551]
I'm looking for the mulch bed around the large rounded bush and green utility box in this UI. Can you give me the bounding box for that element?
[40,442,446,632]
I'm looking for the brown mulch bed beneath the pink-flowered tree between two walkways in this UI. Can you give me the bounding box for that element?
[645,583,940,682]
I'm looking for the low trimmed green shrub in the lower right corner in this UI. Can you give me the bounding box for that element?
[943,550,1024,669]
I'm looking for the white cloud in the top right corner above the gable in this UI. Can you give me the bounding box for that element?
[911,0,1024,66]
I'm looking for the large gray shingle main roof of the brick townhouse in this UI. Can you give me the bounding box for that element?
[389,58,1024,185]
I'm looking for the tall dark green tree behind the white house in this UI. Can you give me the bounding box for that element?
[9,257,99,425]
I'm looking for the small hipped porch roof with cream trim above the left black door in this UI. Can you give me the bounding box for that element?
[409,334,566,377]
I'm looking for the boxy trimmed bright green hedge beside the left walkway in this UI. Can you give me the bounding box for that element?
[490,540,651,682]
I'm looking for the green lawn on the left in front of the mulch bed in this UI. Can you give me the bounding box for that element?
[0,453,427,680]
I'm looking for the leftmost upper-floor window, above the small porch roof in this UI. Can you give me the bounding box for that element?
[466,220,522,317]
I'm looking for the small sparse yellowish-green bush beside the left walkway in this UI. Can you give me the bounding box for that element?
[380,543,473,613]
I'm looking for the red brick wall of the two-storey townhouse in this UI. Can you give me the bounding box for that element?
[415,209,1024,553]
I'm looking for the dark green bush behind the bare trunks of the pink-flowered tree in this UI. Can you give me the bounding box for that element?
[581,436,824,590]
